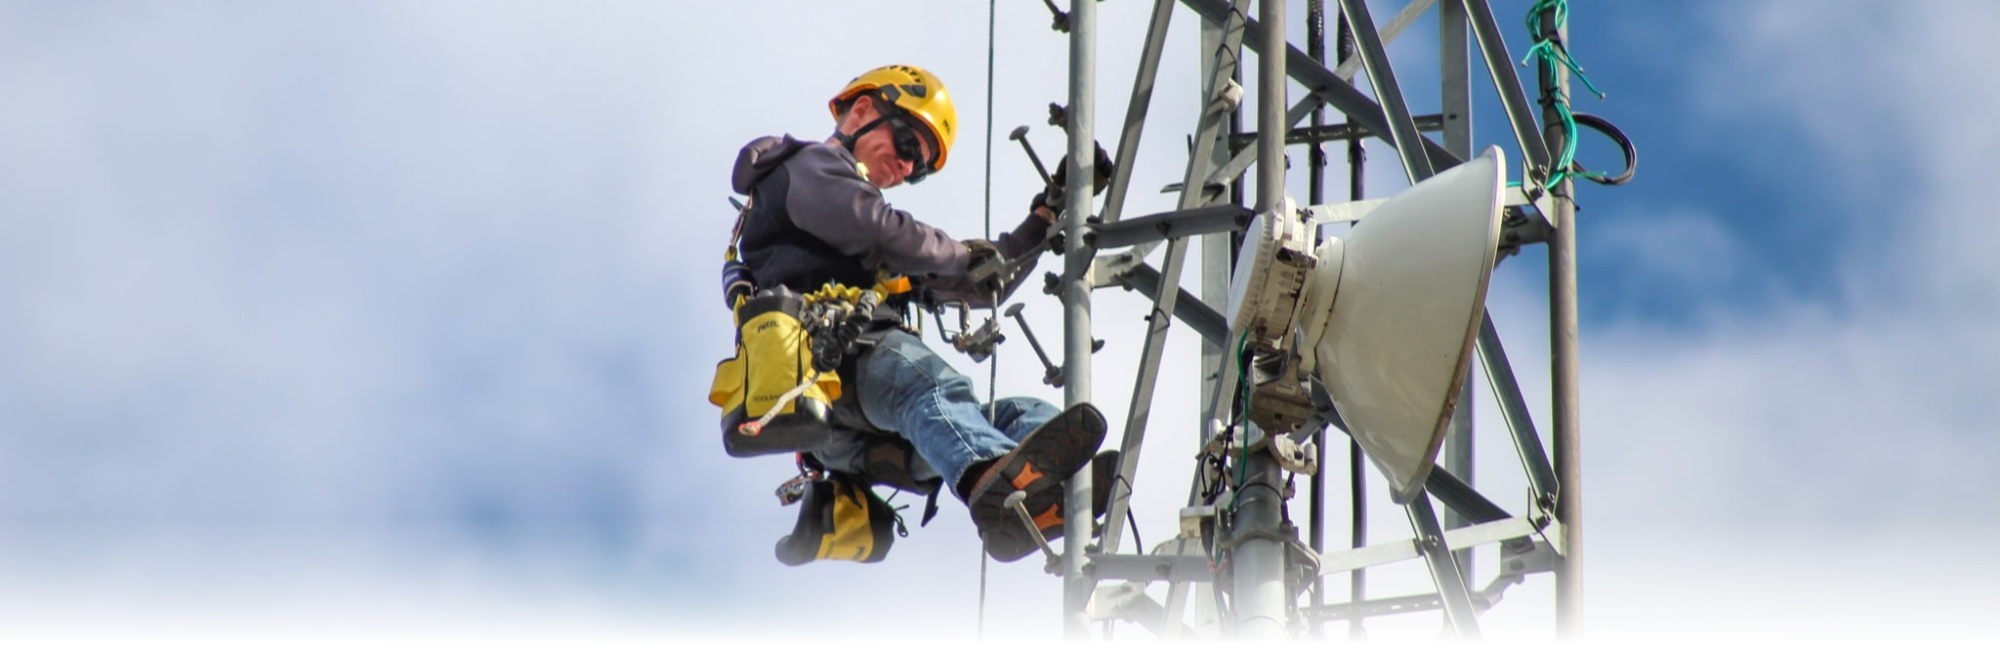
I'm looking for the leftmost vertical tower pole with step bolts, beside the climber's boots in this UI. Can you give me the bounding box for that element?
[1062,2,1098,643]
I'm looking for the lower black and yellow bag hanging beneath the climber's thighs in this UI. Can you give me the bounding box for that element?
[778,475,910,567]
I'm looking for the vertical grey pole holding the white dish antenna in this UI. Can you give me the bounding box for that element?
[1232,0,1290,643]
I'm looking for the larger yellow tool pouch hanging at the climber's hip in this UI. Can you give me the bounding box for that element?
[708,286,840,459]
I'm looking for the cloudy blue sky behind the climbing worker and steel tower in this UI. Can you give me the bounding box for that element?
[0,0,2000,641]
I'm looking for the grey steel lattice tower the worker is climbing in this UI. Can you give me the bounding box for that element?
[1024,0,1584,641]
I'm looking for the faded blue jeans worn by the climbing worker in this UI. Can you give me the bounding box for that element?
[854,331,1060,491]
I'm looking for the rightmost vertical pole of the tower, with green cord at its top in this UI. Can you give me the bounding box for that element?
[1540,6,1584,643]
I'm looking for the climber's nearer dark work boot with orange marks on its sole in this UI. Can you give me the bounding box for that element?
[966,403,1116,563]
